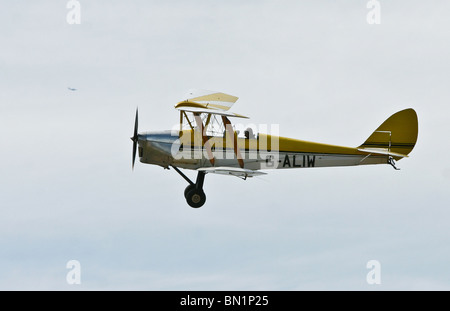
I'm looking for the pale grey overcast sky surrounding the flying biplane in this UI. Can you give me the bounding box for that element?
[0,0,450,290]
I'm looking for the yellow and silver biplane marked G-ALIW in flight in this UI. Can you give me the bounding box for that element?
[131,90,418,208]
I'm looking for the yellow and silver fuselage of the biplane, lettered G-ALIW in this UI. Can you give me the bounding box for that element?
[138,130,388,170]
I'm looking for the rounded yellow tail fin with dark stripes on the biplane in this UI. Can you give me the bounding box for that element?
[358,108,418,160]
